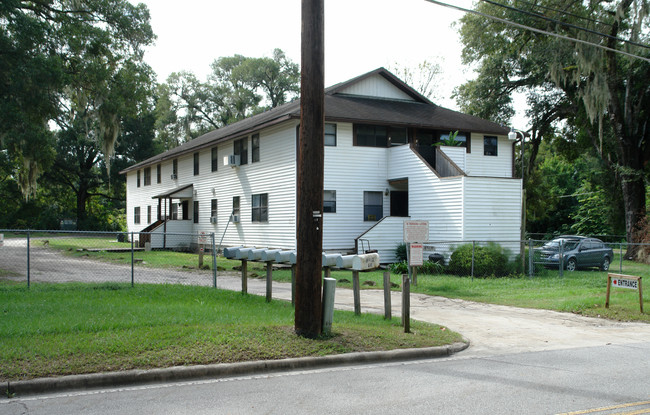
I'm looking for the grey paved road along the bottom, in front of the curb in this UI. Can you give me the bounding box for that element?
[0,342,650,415]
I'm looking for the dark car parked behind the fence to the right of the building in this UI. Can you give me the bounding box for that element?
[540,235,614,271]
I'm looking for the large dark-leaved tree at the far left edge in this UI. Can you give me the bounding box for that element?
[0,0,154,228]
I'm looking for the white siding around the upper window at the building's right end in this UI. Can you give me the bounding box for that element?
[465,133,512,177]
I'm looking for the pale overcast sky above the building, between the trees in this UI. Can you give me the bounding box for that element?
[131,0,528,127]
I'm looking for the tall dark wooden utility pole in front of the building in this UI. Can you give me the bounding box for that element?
[295,0,325,338]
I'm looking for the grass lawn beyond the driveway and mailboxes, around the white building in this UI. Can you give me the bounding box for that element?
[33,238,650,322]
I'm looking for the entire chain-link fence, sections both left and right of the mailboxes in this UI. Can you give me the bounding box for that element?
[0,230,650,287]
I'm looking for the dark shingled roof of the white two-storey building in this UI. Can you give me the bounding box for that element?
[120,68,510,174]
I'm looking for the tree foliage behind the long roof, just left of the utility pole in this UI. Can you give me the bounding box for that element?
[156,49,300,149]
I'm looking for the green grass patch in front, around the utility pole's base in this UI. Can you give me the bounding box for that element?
[0,282,460,380]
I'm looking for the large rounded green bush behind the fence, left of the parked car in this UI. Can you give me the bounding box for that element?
[448,242,512,277]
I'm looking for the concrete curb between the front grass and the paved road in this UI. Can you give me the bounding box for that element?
[0,342,469,396]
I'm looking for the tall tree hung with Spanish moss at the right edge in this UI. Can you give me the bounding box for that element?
[459,0,650,247]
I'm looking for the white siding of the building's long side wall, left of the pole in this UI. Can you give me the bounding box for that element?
[127,122,296,248]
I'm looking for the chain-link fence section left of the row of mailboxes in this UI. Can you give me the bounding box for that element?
[0,230,218,287]
